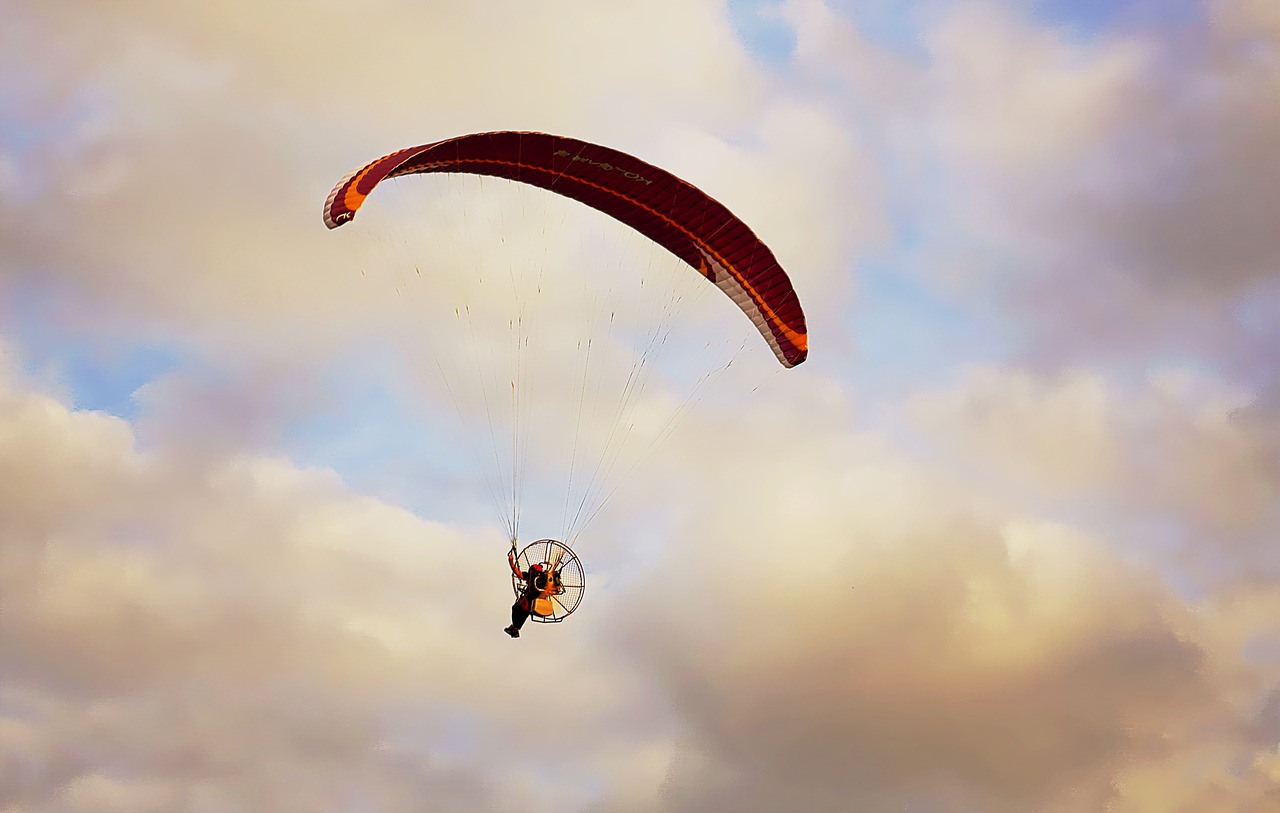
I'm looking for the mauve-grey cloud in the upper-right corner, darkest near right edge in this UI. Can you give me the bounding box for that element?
[936,0,1280,373]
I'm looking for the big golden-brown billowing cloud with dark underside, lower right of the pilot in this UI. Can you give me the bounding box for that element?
[604,419,1228,810]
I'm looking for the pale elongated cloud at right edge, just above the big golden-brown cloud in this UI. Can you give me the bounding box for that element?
[909,367,1280,577]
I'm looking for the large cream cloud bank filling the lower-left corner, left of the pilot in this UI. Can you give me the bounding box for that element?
[0,345,650,810]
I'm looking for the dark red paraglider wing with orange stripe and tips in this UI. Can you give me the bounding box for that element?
[324,131,809,367]
